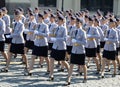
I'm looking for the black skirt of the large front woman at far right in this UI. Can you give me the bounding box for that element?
[103,50,116,60]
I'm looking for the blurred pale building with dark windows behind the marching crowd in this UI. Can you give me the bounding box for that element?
[0,0,120,15]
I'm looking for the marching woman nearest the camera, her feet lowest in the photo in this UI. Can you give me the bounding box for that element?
[66,18,87,85]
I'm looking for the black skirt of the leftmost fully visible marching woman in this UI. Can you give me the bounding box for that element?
[10,43,24,54]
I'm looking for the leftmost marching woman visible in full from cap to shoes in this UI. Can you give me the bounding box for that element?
[1,10,28,72]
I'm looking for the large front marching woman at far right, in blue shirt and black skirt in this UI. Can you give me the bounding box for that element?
[101,19,118,78]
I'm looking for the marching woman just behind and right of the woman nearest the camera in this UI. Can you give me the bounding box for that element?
[86,17,100,73]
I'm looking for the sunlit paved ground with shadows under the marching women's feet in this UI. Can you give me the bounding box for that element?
[0,44,120,87]
